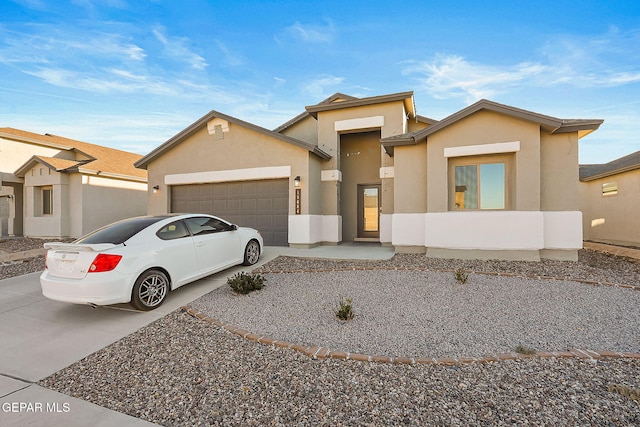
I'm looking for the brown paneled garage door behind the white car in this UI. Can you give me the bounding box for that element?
[171,179,289,246]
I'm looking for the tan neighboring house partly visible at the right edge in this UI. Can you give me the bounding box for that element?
[580,151,640,247]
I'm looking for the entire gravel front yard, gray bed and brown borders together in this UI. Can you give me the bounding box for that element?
[28,247,640,426]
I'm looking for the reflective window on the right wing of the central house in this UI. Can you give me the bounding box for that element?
[450,156,509,210]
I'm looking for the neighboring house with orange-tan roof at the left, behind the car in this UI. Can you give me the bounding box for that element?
[0,128,147,237]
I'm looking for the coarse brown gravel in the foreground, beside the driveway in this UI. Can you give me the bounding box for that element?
[41,312,640,426]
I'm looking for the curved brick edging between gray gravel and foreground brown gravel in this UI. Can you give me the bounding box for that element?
[182,305,640,365]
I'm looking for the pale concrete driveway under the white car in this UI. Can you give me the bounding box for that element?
[0,247,291,426]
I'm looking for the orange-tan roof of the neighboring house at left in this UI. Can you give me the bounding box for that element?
[0,128,147,182]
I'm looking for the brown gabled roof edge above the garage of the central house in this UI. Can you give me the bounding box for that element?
[135,110,331,169]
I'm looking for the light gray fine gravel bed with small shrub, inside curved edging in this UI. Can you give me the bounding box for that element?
[191,270,640,357]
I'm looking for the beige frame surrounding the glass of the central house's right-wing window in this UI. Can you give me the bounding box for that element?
[447,153,515,212]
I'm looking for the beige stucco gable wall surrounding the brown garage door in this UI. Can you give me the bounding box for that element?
[147,123,318,215]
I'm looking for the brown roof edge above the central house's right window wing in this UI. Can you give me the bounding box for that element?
[381,99,604,152]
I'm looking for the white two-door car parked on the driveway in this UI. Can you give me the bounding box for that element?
[40,214,263,310]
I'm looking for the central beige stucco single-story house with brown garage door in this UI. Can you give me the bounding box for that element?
[136,92,602,260]
